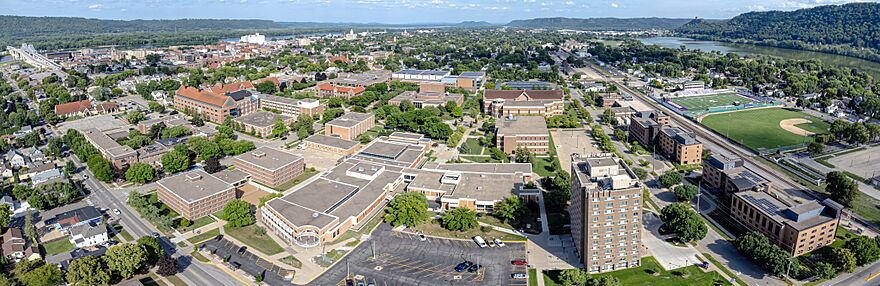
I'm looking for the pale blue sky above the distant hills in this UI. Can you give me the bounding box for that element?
[0,0,880,24]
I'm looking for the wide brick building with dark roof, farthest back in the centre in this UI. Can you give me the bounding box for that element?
[483,90,565,117]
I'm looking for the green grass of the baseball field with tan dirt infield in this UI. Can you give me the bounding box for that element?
[700,108,830,151]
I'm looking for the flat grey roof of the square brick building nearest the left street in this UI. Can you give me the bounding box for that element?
[156,169,232,202]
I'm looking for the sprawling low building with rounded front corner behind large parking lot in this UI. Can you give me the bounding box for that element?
[257,138,428,247]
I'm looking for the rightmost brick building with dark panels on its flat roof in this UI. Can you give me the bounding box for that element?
[730,191,843,256]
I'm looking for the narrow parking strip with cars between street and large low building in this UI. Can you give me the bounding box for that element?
[198,239,292,285]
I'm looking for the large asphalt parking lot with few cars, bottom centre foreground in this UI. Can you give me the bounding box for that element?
[311,224,528,285]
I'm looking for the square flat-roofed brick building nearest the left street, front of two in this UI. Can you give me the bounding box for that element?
[156,169,235,220]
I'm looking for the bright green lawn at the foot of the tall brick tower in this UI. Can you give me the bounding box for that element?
[544,256,730,286]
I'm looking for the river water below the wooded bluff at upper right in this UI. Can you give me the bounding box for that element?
[639,37,880,79]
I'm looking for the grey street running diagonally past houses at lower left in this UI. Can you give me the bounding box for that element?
[71,139,244,285]
